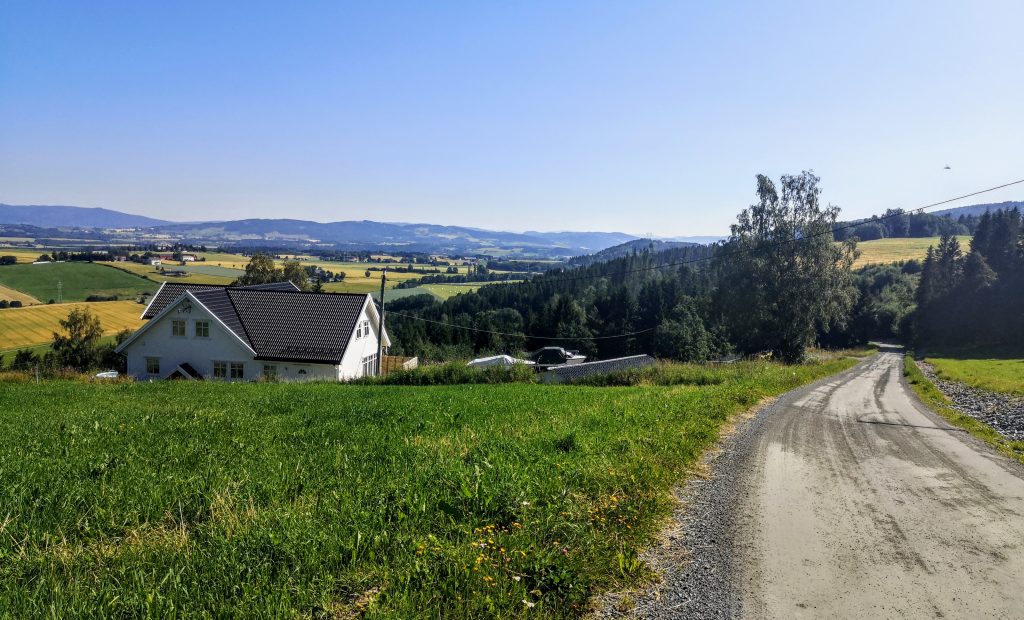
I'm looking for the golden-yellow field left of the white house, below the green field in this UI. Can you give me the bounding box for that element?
[0,301,144,352]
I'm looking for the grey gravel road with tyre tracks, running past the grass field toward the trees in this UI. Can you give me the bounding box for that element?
[599,348,1024,618]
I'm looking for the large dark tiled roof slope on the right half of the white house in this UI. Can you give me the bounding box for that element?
[226,288,367,364]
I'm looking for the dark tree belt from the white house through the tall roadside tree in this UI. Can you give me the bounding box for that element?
[388,172,857,361]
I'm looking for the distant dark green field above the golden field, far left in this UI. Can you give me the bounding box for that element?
[0,262,158,302]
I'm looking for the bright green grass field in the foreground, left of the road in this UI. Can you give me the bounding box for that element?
[0,359,853,618]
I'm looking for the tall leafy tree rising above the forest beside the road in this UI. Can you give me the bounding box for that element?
[715,171,856,362]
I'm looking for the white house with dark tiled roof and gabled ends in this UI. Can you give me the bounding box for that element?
[117,282,391,381]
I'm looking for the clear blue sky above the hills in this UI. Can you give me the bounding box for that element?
[0,0,1024,236]
